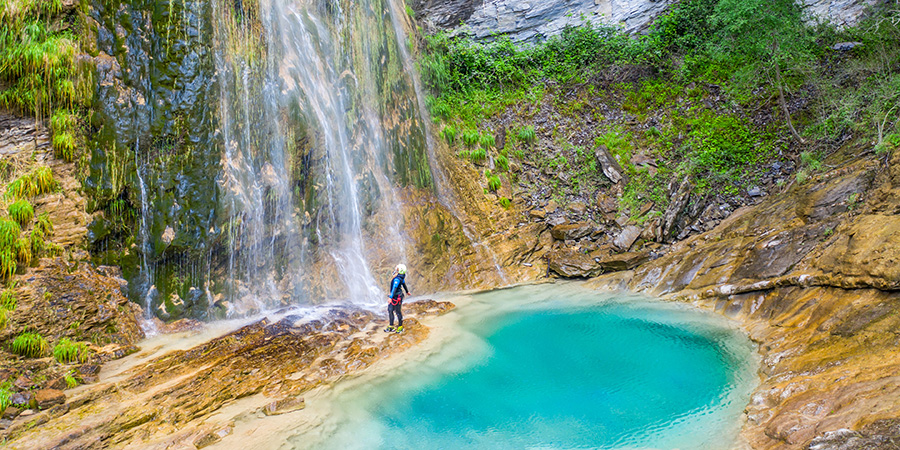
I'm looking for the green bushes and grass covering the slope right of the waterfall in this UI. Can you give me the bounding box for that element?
[419,0,900,208]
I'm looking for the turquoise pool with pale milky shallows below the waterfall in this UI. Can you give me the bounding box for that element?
[293,284,757,449]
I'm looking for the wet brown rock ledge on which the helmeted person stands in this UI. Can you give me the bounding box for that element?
[3,300,454,449]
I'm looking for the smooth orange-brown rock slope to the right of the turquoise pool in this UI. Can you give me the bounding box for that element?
[591,149,900,450]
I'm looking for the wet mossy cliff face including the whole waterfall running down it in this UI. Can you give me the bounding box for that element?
[85,0,492,320]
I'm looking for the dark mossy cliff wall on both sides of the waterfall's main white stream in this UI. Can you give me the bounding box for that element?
[84,0,442,318]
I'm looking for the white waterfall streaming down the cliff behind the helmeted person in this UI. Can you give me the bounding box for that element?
[213,0,430,314]
